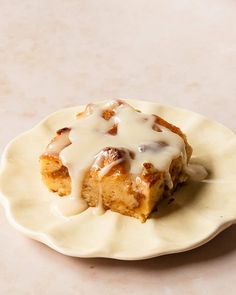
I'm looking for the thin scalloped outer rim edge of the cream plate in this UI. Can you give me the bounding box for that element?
[0,99,236,261]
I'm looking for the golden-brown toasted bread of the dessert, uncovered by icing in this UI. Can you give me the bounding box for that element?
[40,101,192,222]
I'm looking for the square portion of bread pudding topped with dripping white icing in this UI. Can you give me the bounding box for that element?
[40,100,192,222]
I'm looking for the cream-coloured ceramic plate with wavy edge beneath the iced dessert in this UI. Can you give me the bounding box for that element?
[0,100,236,260]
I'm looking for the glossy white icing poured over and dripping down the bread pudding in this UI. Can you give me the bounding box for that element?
[52,102,191,215]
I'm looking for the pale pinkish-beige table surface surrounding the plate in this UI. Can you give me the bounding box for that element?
[0,0,236,295]
